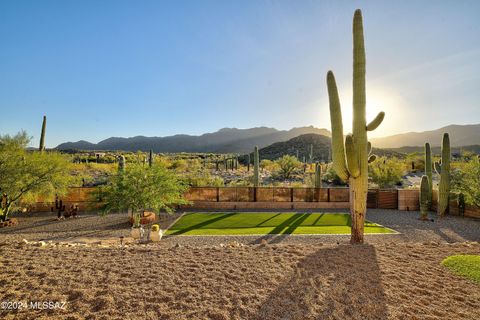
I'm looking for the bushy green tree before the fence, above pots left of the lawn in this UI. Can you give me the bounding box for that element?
[100,162,188,213]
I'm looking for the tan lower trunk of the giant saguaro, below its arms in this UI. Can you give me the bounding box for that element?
[350,177,368,244]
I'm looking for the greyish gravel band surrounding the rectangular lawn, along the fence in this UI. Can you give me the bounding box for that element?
[0,209,480,246]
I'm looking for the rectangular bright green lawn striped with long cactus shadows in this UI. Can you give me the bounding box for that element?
[166,212,394,235]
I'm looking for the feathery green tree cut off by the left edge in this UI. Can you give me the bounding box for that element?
[0,131,73,221]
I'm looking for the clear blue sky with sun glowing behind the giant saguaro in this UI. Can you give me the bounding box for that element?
[0,0,480,147]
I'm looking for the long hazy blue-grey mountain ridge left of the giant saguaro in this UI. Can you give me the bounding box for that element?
[56,126,330,153]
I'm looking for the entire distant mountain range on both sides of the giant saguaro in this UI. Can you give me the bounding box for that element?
[56,124,480,154]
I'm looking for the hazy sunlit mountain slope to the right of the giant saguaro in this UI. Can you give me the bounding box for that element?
[371,124,480,148]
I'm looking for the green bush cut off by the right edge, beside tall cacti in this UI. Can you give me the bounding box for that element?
[451,157,480,207]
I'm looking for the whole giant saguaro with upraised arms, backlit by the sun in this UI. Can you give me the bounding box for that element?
[327,10,385,243]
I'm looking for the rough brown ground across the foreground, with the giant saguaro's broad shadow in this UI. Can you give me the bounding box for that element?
[0,241,480,319]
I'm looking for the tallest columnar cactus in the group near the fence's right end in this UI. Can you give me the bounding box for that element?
[435,133,450,216]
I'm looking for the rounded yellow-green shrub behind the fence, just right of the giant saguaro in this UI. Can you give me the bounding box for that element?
[368,157,404,188]
